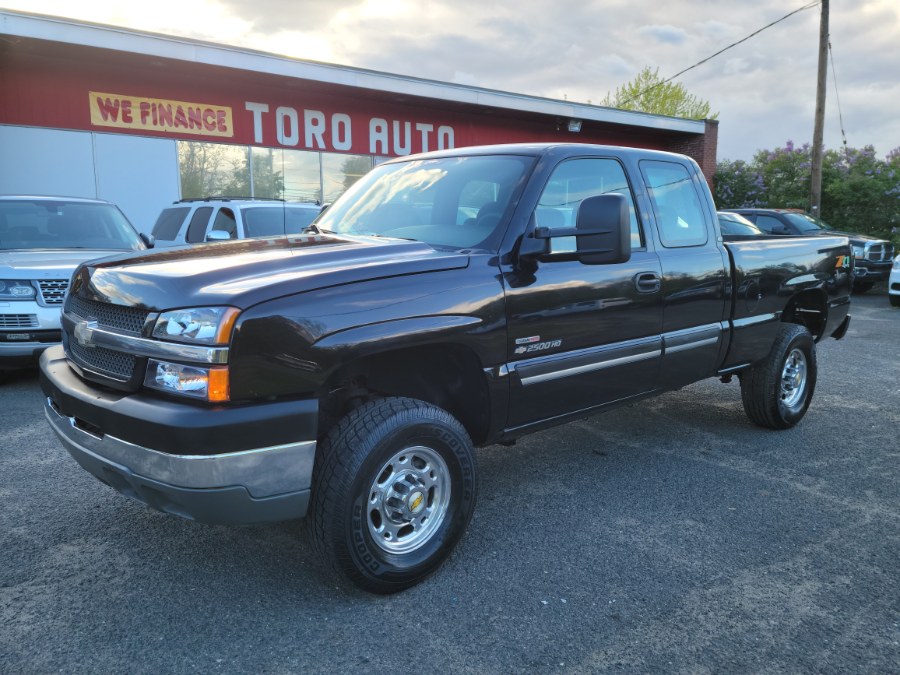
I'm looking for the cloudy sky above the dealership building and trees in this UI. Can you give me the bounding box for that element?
[0,0,900,159]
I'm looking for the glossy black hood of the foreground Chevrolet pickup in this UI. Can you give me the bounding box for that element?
[71,234,469,311]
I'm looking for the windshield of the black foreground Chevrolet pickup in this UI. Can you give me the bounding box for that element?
[316,155,534,249]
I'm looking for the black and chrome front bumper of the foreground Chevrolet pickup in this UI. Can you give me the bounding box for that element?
[41,348,317,525]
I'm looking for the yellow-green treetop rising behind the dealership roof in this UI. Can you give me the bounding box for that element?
[601,66,719,120]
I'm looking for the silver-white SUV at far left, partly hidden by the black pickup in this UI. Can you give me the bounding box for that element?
[0,195,150,371]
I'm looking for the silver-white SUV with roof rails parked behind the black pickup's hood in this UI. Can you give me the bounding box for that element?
[153,197,322,248]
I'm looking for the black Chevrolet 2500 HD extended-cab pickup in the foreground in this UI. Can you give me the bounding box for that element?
[41,145,853,592]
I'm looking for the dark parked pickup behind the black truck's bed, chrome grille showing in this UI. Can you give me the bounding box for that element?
[729,209,894,293]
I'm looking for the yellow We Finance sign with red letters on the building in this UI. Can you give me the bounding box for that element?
[88,91,234,138]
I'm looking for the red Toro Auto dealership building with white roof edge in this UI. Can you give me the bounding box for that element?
[0,10,717,232]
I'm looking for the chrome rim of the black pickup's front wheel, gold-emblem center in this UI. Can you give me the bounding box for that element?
[366,445,450,553]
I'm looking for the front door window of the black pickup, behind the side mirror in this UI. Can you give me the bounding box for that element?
[534,159,644,251]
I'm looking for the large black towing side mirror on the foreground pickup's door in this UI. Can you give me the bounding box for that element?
[519,194,631,265]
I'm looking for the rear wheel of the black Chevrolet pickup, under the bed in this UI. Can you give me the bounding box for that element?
[740,323,817,429]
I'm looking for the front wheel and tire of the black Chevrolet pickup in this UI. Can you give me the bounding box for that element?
[308,398,476,593]
